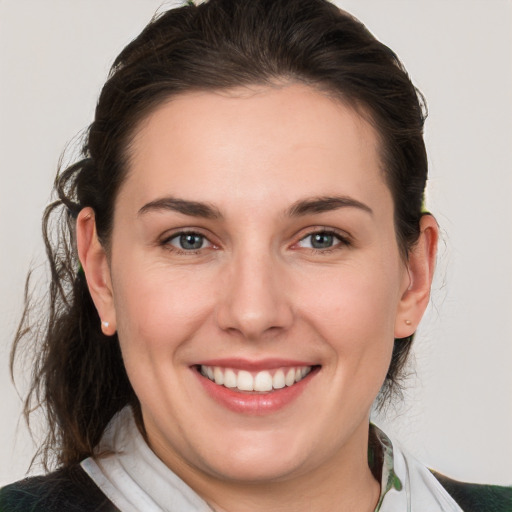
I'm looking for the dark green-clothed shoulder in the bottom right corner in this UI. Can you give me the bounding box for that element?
[432,471,512,512]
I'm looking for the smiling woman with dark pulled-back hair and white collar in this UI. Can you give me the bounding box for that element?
[0,0,511,512]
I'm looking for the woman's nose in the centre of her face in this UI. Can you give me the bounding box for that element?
[217,250,293,341]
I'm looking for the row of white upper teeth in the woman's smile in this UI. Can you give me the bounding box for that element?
[200,365,311,392]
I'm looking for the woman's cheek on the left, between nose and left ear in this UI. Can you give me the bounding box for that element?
[113,260,219,417]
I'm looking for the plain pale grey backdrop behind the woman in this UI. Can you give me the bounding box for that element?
[0,0,512,485]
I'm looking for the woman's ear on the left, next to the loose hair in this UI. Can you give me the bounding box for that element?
[76,208,116,336]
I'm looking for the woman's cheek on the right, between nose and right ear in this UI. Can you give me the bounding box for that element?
[296,260,401,376]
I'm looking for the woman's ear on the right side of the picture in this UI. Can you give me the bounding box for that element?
[395,214,439,338]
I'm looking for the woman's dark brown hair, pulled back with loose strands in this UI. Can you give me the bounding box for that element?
[11,0,427,468]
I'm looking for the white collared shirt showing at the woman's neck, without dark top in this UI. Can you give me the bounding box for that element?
[81,407,463,512]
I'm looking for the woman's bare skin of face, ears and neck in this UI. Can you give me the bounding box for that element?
[77,84,437,512]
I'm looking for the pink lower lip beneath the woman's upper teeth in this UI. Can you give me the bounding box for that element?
[194,367,318,416]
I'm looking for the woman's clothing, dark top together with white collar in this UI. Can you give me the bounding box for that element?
[0,408,512,512]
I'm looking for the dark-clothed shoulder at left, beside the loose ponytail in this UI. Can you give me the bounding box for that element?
[0,465,117,512]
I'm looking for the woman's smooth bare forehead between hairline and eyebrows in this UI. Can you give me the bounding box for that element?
[121,84,387,214]
